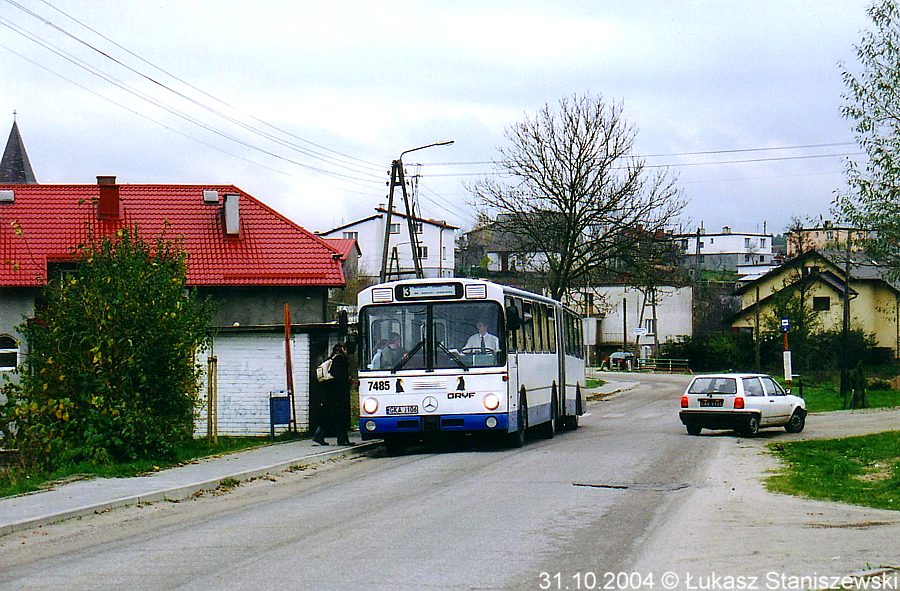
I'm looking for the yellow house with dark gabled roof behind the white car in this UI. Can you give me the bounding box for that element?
[732,251,900,358]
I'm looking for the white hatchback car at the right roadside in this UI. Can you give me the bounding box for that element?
[679,373,806,435]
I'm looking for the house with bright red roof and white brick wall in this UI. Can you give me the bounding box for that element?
[0,155,349,434]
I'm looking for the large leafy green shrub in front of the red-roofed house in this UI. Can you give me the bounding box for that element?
[3,229,211,469]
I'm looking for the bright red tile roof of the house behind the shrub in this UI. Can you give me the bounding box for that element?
[0,185,344,287]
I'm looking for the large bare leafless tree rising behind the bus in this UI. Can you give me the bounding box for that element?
[471,94,684,298]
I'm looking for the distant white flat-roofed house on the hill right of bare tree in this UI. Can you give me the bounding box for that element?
[673,226,773,271]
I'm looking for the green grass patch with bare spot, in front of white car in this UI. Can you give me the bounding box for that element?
[766,431,900,511]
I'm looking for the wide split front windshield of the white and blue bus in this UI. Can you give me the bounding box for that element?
[359,302,506,371]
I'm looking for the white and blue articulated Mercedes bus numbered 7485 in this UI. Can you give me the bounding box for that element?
[359,279,585,453]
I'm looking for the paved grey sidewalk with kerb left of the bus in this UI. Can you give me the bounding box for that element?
[0,432,381,536]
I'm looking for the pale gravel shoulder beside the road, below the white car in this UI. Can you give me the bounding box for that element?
[634,409,900,588]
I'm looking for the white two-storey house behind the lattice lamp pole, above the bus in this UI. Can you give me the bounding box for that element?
[318,206,459,280]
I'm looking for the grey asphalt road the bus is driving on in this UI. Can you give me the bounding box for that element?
[0,377,727,590]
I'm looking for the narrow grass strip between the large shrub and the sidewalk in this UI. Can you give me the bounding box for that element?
[0,433,300,497]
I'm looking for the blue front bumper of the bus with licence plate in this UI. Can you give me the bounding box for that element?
[359,413,509,440]
